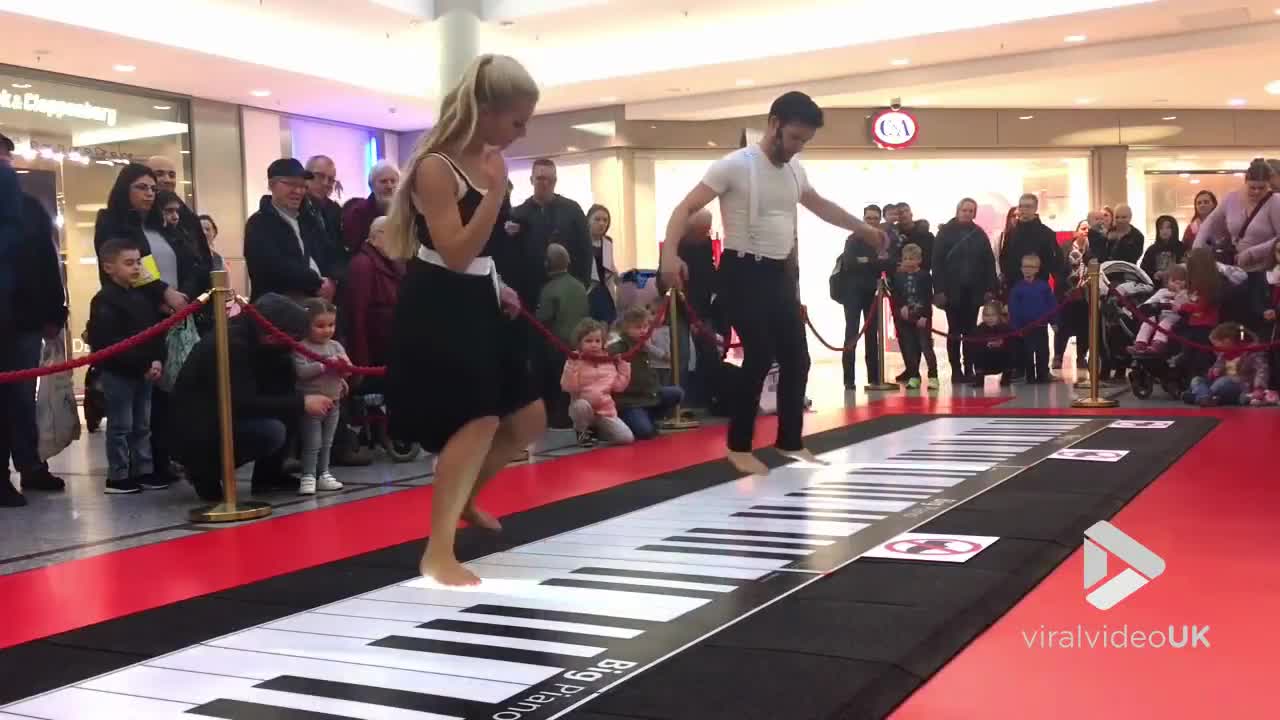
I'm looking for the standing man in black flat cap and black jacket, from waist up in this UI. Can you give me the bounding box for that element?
[244,158,334,301]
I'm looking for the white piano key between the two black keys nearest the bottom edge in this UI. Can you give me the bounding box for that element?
[81,665,458,720]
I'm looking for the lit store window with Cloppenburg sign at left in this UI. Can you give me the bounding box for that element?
[0,65,195,384]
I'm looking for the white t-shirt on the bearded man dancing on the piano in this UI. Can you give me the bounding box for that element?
[703,145,810,260]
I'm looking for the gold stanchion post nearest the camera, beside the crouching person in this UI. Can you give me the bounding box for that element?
[189,270,271,523]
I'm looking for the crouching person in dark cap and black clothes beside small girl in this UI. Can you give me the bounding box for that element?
[172,292,333,502]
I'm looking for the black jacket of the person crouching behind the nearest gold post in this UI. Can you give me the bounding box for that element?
[170,315,302,460]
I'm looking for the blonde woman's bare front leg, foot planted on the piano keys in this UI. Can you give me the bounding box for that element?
[419,418,499,585]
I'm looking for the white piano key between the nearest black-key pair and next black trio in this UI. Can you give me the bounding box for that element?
[209,628,564,685]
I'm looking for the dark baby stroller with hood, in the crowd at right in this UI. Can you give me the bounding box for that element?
[1100,260,1190,400]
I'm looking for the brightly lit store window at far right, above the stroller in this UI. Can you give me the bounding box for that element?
[1128,149,1280,243]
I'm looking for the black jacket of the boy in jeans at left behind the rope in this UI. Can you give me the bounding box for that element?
[86,281,165,378]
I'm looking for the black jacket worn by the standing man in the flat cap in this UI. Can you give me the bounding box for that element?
[244,195,328,300]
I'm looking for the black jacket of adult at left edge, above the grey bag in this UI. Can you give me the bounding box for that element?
[13,193,67,332]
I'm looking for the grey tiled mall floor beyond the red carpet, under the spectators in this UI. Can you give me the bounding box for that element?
[0,348,1169,575]
